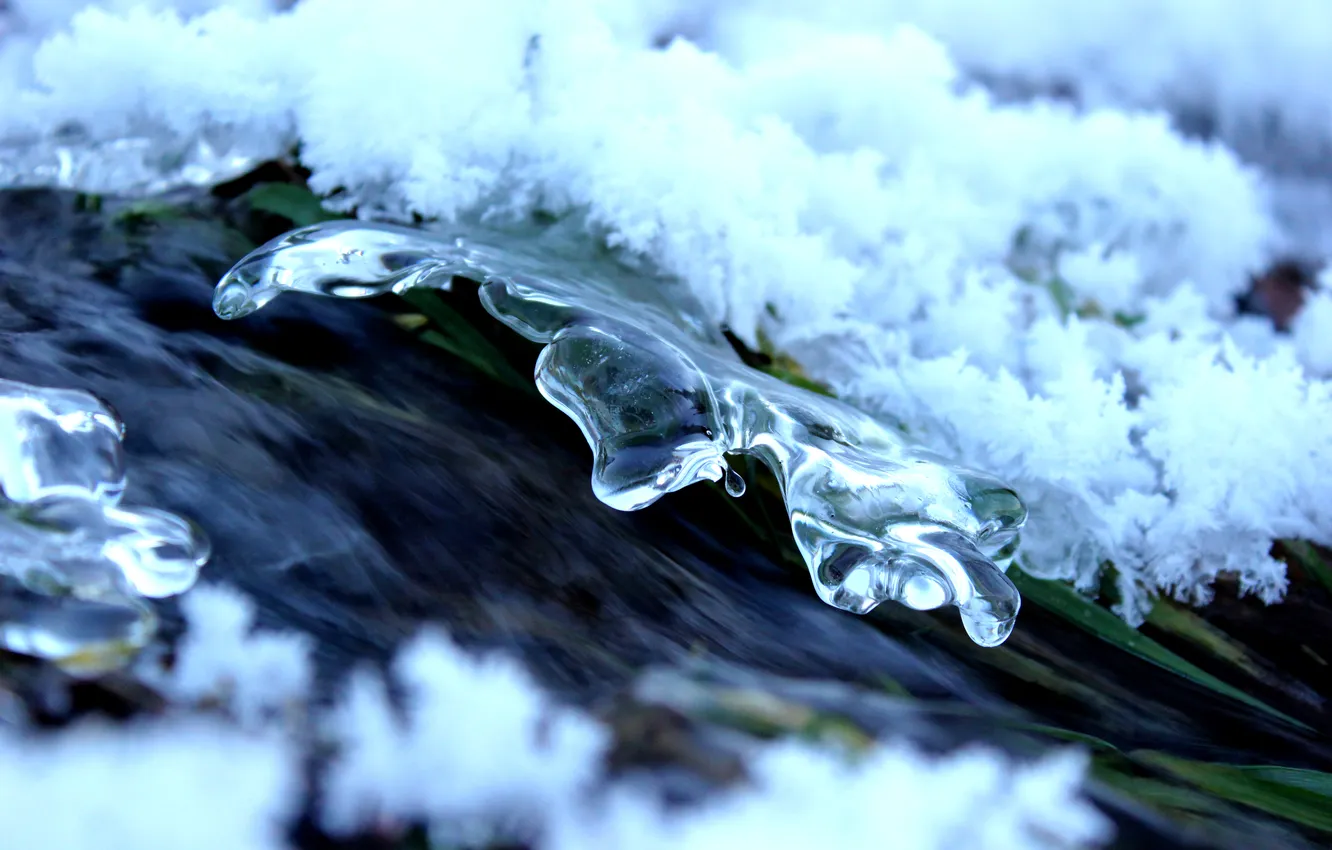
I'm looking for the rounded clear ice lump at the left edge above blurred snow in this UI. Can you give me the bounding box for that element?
[0,380,209,673]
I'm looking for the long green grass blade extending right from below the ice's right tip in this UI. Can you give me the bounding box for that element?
[1008,568,1309,730]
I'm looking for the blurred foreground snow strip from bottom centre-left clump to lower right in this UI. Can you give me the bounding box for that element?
[324,623,1110,850]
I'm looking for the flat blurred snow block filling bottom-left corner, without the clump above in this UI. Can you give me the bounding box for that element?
[0,718,300,850]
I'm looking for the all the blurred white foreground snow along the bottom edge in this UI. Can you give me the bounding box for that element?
[0,586,1108,850]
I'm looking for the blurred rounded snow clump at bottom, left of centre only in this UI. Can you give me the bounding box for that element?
[319,633,606,831]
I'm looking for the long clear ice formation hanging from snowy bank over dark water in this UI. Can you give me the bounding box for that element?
[213,221,1027,646]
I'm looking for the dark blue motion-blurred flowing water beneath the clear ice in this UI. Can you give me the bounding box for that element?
[0,191,1332,847]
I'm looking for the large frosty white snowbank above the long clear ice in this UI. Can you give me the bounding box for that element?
[0,0,1332,621]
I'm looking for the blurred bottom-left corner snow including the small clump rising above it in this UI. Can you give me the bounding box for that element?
[0,586,312,850]
